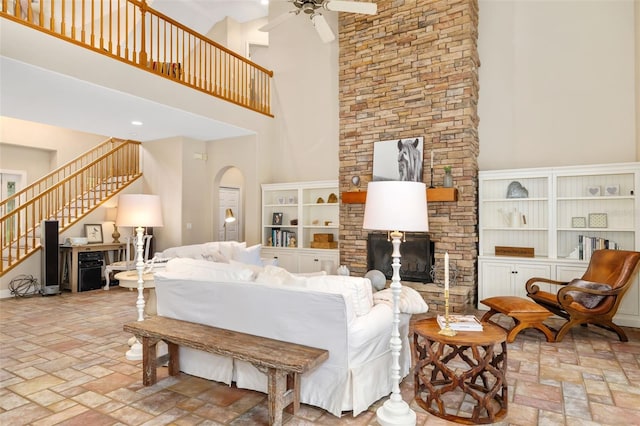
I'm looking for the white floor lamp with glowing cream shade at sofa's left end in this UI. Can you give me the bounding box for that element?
[116,194,162,361]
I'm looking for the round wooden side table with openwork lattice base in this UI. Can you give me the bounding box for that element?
[413,318,508,424]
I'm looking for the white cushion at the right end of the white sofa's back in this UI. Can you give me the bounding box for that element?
[306,275,373,316]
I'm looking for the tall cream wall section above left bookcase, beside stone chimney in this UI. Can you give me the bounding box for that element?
[256,2,339,182]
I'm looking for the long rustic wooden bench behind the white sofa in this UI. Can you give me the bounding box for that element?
[123,316,329,425]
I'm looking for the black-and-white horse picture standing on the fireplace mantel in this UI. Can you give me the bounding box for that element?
[373,137,424,182]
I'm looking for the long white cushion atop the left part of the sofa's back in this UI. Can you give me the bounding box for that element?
[165,258,254,282]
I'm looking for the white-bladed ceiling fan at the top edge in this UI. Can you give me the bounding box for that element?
[259,0,378,43]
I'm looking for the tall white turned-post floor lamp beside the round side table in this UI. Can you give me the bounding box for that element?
[362,181,429,426]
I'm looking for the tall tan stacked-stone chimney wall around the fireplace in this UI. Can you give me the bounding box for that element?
[339,0,480,311]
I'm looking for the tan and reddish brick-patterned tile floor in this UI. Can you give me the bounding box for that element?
[0,287,640,426]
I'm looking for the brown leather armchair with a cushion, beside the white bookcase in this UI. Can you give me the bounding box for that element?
[526,250,640,342]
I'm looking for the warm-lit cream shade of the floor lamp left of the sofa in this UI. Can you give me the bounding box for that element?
[116,194,162,227]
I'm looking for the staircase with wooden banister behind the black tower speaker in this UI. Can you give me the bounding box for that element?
[0,138,142,276]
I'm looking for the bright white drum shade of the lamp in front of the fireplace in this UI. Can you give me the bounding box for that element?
[362,181,429,232]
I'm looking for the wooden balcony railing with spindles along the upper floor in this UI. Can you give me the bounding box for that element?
[0,0,273,116]
